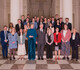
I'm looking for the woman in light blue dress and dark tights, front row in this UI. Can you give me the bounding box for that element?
[8,28,18,60]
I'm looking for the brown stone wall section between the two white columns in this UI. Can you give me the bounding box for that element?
[24,0,59,17]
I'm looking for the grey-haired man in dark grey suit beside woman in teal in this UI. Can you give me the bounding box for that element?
[36,24,45,60]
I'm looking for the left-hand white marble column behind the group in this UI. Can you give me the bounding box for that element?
[10,0,23,26]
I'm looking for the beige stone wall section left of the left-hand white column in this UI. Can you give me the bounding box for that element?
[0,0,10,30]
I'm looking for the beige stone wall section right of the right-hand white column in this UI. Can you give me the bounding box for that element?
[73,0,80,33]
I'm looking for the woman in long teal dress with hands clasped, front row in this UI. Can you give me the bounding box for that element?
[26,24,37,60]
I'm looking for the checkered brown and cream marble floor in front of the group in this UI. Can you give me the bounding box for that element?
[0,56,80,70]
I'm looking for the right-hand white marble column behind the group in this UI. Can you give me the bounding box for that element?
[60,0,73,23]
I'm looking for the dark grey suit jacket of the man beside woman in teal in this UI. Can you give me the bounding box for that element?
[37,29,45,44]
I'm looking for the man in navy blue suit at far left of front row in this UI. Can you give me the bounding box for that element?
[0,25,9,59]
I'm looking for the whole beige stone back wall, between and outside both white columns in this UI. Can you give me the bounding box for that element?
[0,0,80,33]
